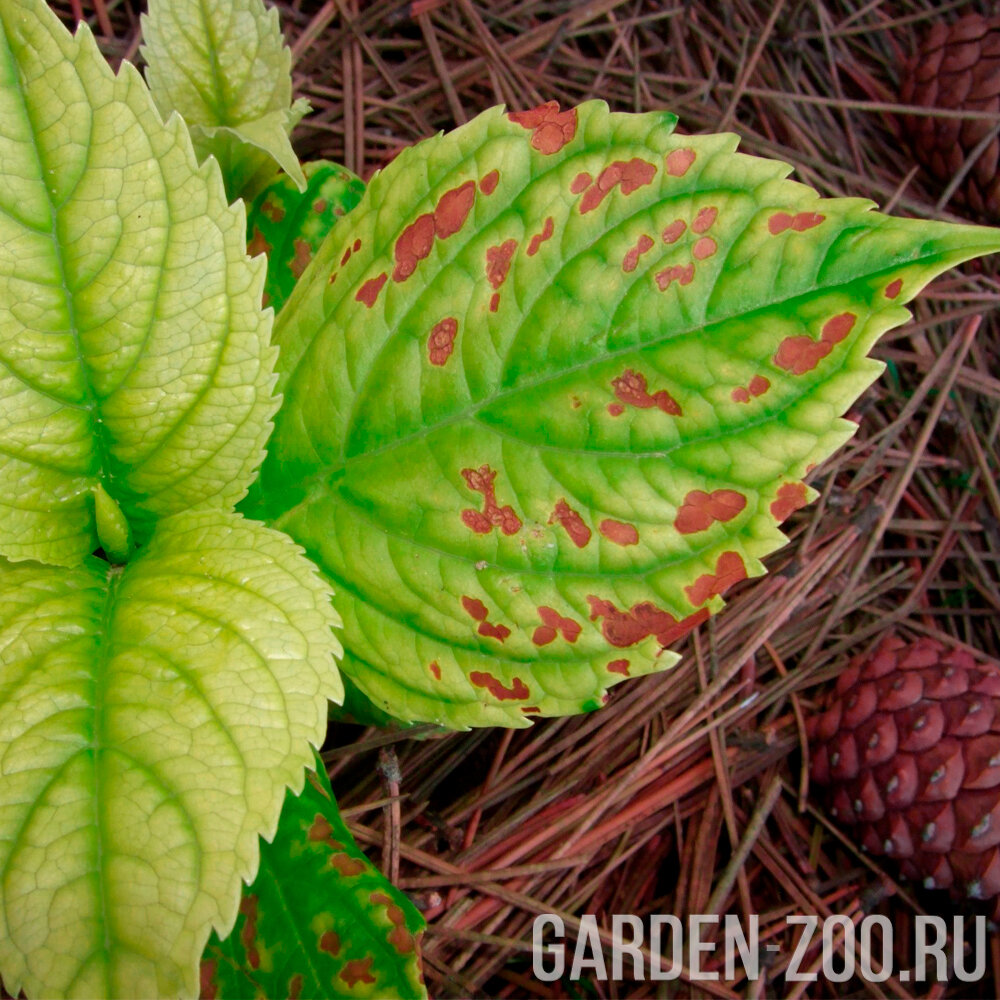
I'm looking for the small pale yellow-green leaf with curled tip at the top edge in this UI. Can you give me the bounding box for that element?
[142,0,309,199]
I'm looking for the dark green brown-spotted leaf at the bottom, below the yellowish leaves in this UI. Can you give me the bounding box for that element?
[201,760,427,1000]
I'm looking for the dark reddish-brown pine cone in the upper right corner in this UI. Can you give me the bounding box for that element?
[899,14,1000,219]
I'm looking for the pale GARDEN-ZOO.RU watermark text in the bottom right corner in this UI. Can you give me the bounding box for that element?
[532,913,987,983]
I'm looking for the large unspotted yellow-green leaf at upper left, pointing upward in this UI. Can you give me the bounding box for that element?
[0,0,277,565]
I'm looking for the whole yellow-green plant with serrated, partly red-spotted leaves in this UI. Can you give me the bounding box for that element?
[0,0,1000,997]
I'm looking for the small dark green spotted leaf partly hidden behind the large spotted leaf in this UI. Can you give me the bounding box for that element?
[247,160,365,312]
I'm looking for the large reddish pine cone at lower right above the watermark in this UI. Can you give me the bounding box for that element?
[808,635,1000,903]
